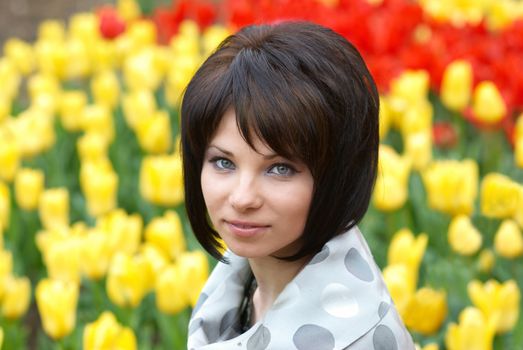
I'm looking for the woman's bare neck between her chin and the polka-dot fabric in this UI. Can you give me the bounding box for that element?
[249,257,310,324]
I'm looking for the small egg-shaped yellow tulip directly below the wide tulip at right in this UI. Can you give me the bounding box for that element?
[448,214,482,255]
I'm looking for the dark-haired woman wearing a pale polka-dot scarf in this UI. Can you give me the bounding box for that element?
[181,22,414,350]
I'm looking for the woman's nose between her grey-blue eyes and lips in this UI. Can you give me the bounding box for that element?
[229,175,263,211]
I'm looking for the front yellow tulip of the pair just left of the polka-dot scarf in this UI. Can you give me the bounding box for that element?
[155,264,189,314]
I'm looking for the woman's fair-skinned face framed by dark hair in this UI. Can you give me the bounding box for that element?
[201,109,313,258]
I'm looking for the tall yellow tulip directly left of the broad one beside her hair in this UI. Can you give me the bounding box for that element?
[80,162,118,217]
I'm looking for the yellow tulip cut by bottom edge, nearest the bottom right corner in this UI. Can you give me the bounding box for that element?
[445,307,494,350]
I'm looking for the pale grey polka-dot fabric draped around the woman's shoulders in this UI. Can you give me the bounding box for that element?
[187,227,414,350]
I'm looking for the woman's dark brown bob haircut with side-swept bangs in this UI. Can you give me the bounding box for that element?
[181,22,379,261]
